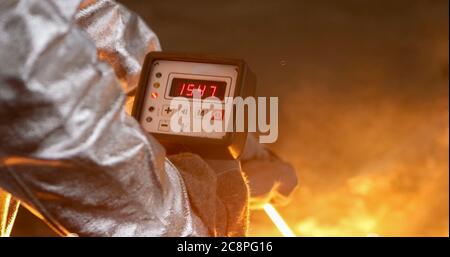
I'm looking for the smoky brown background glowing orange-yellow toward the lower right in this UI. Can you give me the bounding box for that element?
[13,0,449,236]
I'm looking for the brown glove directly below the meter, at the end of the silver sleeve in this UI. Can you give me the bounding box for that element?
[169,153,249,236]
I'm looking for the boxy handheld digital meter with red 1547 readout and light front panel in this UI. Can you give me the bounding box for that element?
[132,52,256,159]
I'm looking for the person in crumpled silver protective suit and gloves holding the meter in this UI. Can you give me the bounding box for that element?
[0,0,297,236]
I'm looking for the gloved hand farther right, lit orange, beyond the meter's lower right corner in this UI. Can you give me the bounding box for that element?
[241,135,298,209]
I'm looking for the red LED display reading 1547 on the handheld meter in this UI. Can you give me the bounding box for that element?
[169,78,227,100]
